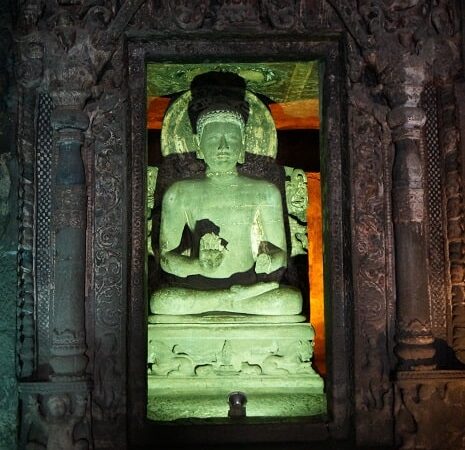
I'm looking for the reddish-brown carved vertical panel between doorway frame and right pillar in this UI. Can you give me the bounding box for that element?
[349,79,393,444]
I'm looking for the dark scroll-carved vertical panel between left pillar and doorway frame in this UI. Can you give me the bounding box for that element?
[87,47,127,448]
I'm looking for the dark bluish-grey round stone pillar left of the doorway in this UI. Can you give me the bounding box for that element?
[50,89,89,381]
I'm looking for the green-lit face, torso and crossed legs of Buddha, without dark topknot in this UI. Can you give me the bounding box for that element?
[150,107,302,315]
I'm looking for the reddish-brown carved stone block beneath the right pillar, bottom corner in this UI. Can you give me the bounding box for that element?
[395,370,465,450]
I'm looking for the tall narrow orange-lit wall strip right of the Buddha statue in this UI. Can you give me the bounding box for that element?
[307,172,326,375]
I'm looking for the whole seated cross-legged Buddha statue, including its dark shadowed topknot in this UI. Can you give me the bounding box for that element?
[150,73,302,315]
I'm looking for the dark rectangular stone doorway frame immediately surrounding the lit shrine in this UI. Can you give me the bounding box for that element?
[127,36,354,445]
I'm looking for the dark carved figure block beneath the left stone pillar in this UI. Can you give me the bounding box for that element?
[19,381,91,450]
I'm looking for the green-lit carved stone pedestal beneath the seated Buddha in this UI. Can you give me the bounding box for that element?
[148,315,326,420]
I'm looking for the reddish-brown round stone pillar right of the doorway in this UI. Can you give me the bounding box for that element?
[386,59,435,370]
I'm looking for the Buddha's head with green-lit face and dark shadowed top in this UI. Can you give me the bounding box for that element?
[189,72,249,172]
